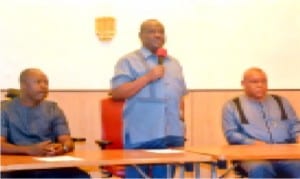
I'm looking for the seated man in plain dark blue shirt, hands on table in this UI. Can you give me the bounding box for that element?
[1,69,90,178]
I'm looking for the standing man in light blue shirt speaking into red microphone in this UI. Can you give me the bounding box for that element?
[111,19,187,178]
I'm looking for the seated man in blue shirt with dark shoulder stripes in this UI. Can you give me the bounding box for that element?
[222,68,300,178]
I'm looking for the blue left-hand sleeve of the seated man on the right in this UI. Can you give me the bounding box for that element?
[222,101,253,144]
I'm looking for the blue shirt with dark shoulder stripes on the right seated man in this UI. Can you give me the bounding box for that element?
[222,95,300,144]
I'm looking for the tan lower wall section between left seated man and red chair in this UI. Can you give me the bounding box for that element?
[48,91,107,146]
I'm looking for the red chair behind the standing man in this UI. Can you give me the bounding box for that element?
[96,97,125,178]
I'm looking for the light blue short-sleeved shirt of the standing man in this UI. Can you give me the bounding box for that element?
[111,48,187,144]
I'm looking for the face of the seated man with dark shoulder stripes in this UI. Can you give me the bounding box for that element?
[242,70,268,100]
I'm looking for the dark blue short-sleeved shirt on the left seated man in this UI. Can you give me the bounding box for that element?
[1,98,70,145]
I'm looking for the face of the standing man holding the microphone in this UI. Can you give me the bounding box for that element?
[140,21,165,53]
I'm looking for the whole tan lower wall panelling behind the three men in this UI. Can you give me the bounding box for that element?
[1,90,300,146]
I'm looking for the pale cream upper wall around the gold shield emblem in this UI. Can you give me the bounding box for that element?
[0,0,300,89]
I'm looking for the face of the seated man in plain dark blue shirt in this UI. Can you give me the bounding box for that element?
[21,71,49,102]
